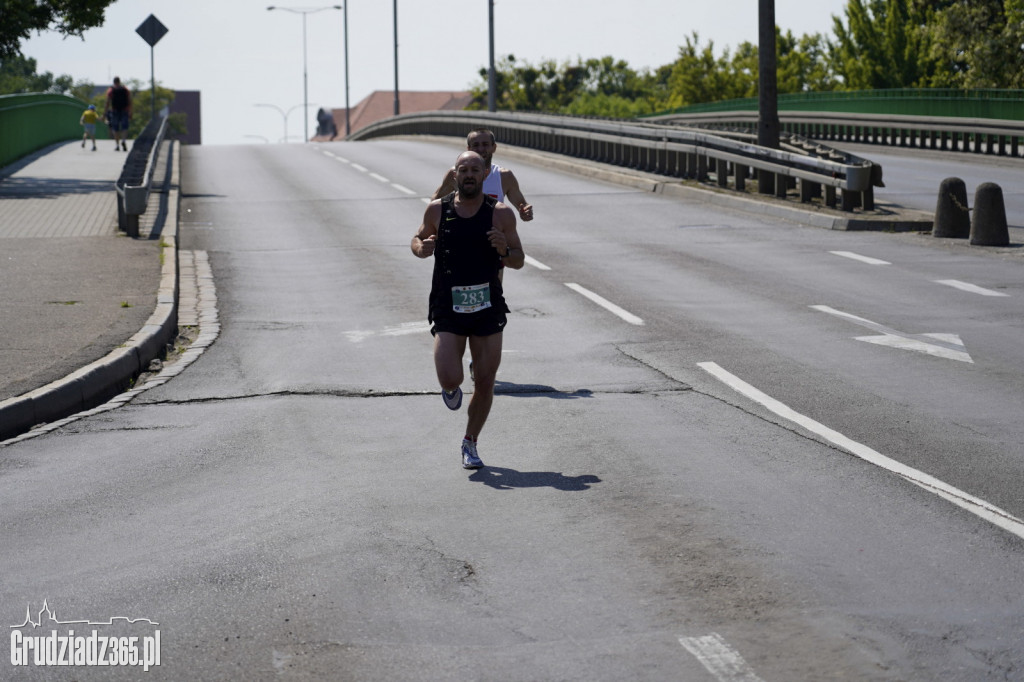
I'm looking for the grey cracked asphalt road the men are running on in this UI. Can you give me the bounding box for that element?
[0,140,1024,682]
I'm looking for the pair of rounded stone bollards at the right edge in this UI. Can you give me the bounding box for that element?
[932,177,1010,246]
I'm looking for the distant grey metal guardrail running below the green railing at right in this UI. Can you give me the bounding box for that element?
[645,111,1024,157]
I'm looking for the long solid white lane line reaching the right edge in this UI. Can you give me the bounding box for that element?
[697,363,1024,538]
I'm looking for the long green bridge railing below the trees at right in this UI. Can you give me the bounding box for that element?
[655,88,1024,121]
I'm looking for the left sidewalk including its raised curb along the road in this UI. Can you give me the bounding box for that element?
[0,140,177,439]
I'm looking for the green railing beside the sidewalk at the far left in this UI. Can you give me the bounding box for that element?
[0,93,106,167]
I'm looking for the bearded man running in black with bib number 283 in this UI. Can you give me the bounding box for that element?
[410,152,525,469]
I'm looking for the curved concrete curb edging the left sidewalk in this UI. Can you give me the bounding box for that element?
[0,143,180,440]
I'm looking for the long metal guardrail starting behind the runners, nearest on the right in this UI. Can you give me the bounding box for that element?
[349,112,882,211]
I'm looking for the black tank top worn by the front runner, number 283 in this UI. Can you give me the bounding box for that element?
[429,193,509,322]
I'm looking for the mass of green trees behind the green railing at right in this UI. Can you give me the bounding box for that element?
[472,0,1024,118]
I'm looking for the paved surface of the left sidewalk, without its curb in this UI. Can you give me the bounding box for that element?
[0,140,176,433]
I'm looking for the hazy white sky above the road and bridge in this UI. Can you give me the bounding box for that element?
[23,0,847,144]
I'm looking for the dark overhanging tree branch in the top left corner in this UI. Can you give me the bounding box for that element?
[0,0,115,60]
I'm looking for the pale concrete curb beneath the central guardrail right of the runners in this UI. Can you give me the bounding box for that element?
[396,135,934,231]
